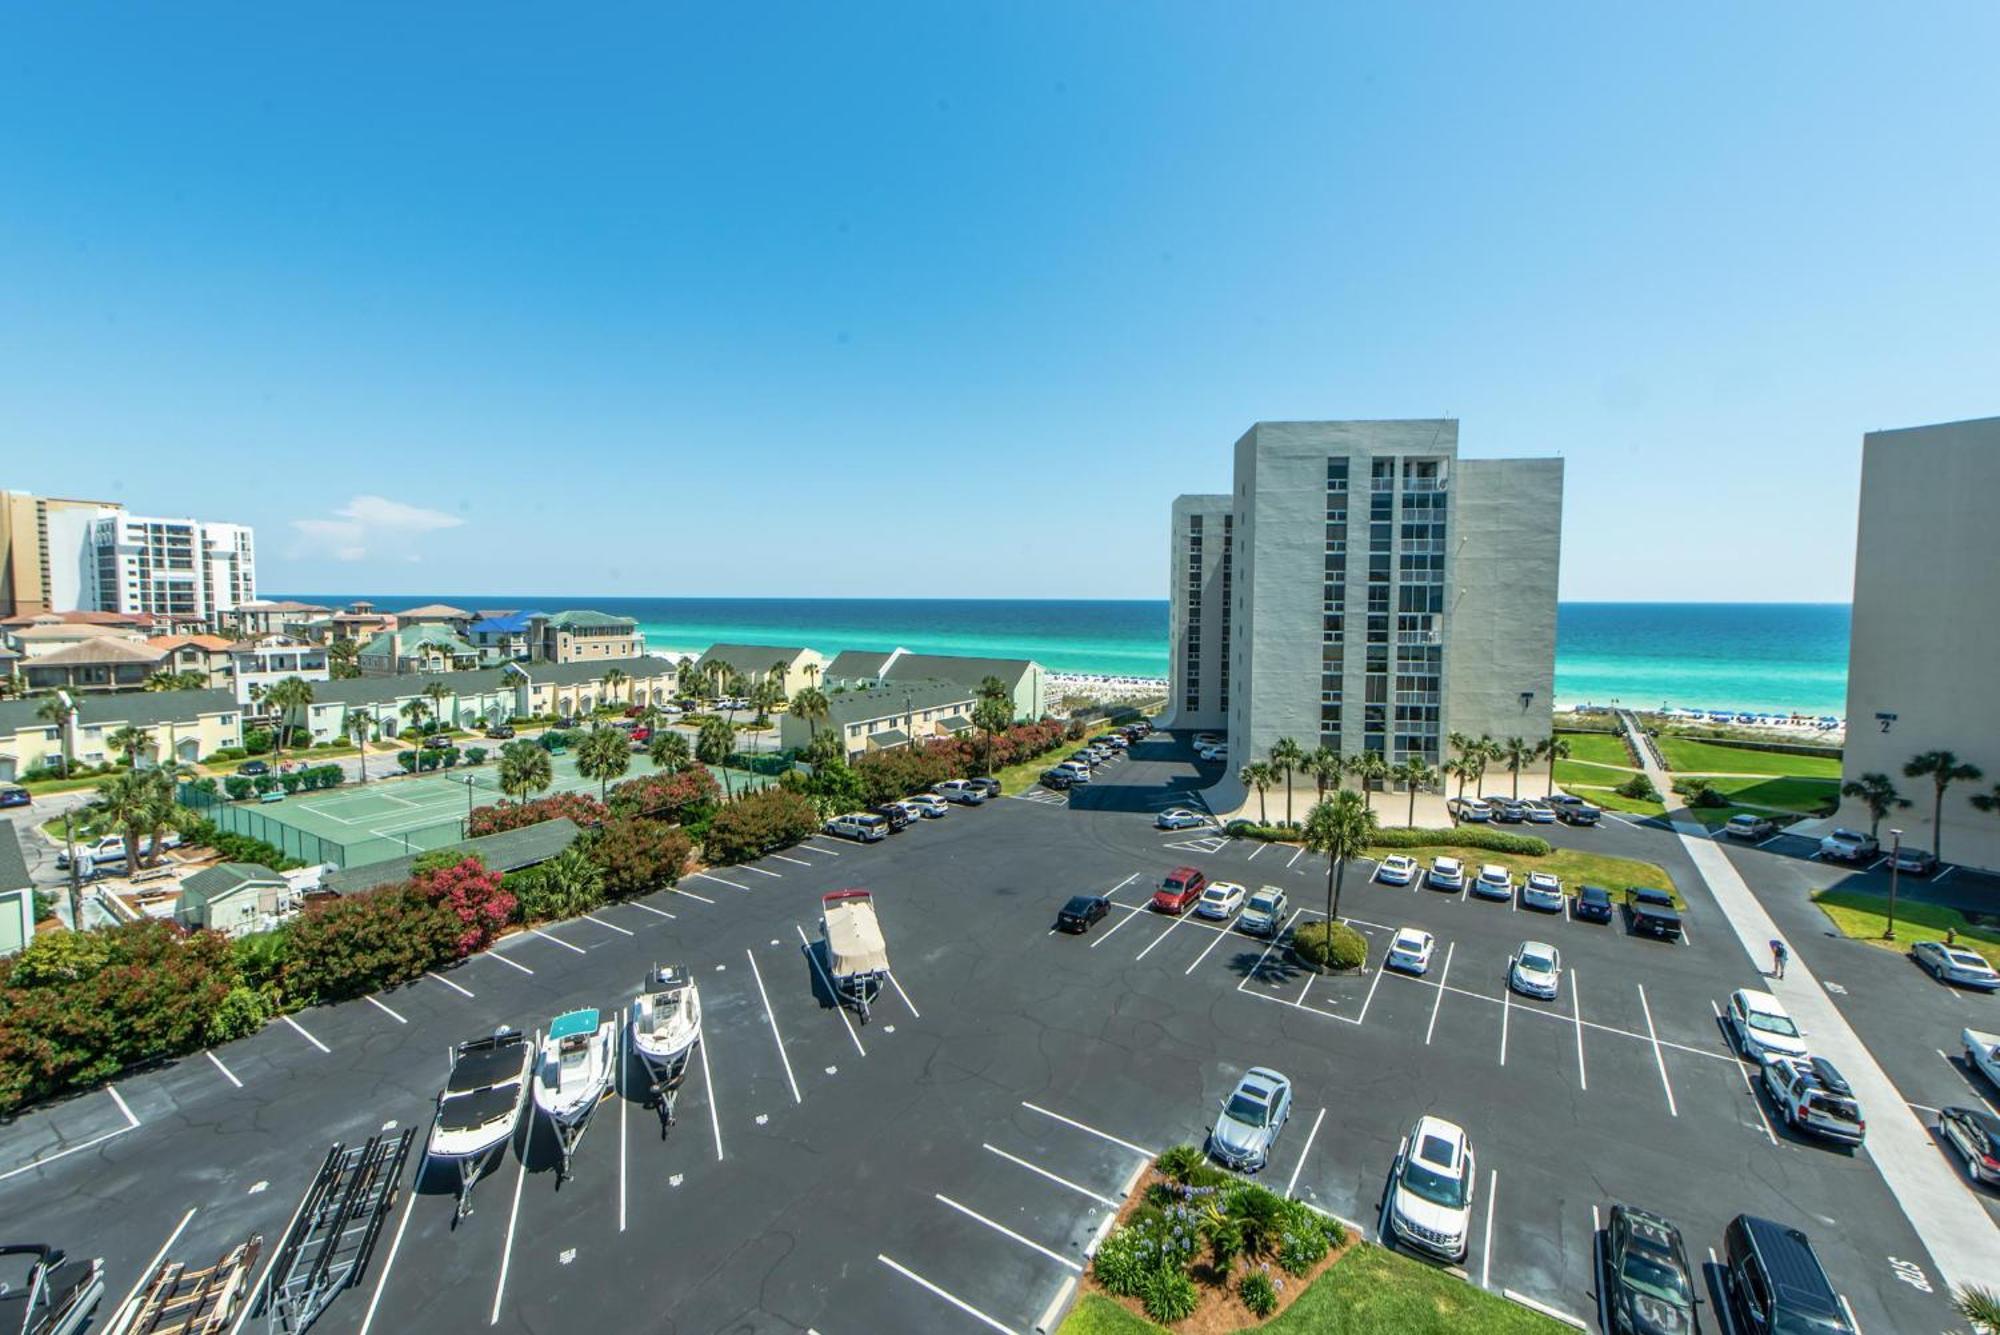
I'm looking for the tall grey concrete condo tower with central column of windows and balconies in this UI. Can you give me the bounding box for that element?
[1170,420,1562,765]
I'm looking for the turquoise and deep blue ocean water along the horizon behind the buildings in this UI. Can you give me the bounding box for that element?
[296,594,1848,715]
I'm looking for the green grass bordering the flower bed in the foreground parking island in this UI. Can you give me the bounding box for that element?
[1058,1243,1568,1335]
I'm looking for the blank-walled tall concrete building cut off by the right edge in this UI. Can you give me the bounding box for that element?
[1838,418,2000,867]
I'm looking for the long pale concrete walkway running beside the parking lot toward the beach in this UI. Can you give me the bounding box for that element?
[1620,713,2000,1289]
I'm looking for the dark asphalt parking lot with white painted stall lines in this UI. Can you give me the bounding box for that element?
[0,737,1968,1335]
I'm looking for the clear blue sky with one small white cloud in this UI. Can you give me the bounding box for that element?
[0,4,2000,600]
